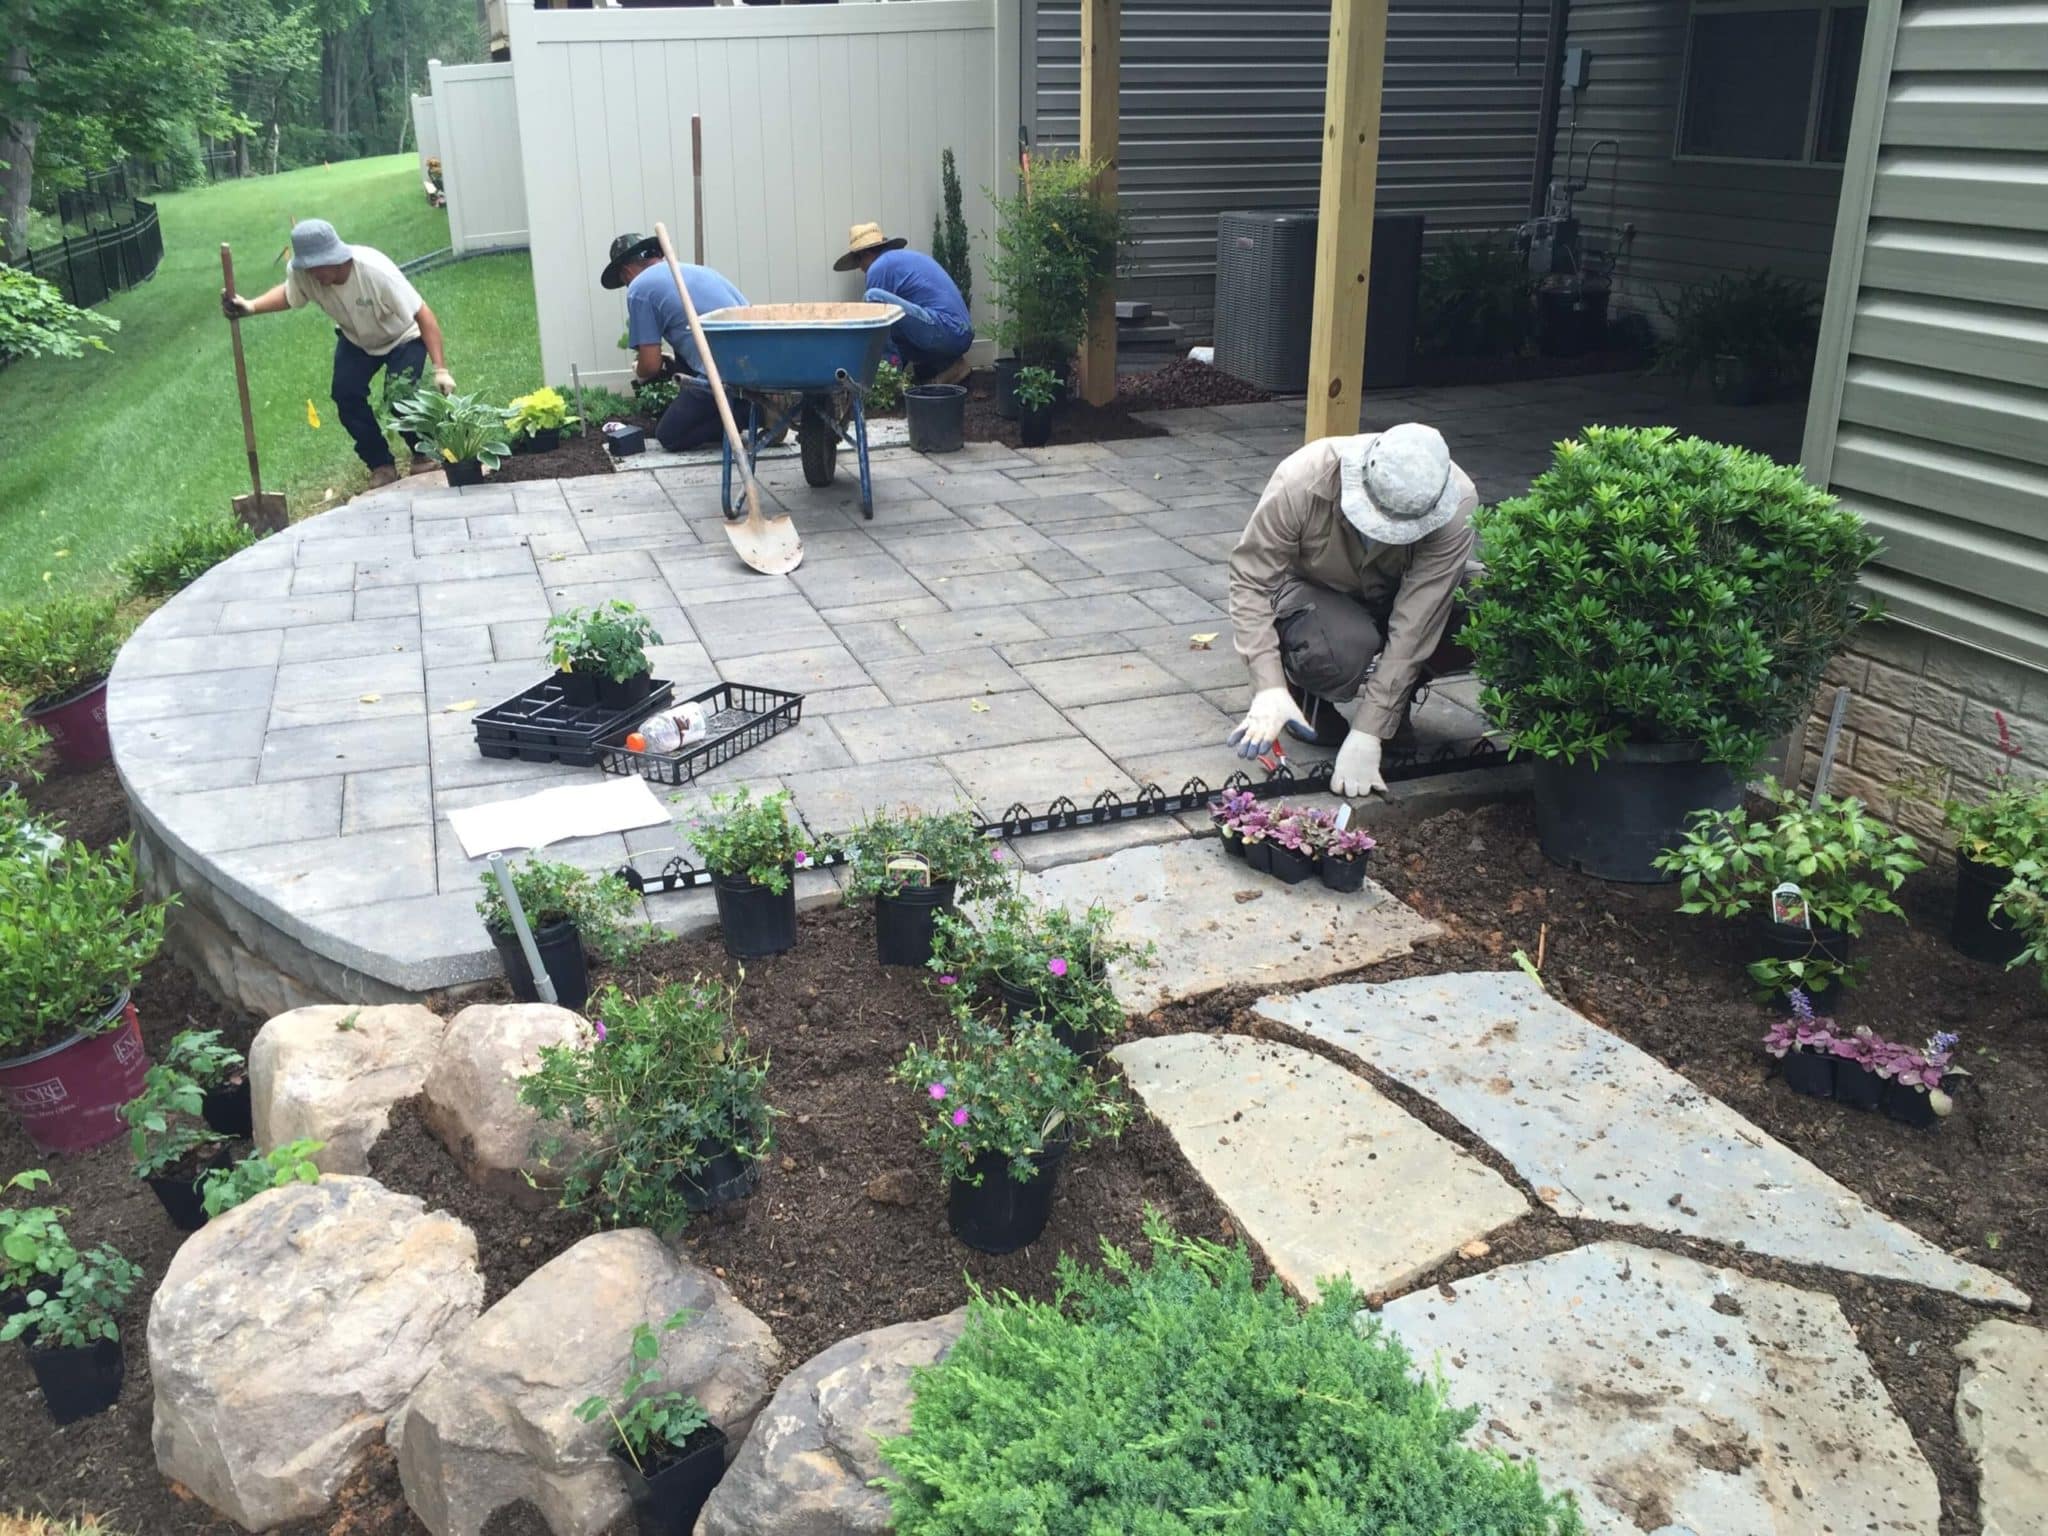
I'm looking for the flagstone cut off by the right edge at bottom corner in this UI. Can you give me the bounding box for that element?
[1956,1321,2048,1536]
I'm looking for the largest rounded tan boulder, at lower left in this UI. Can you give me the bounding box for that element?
[150,1176,483,1530]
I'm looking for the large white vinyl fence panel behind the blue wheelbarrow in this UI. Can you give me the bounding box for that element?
[507,0,1018,387]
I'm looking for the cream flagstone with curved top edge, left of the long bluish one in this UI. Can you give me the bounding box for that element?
[1112,1034,1528,1296]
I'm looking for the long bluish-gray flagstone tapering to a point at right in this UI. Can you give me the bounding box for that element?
[1257,971,2028,1309]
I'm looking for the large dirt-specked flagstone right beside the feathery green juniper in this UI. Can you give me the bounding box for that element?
[1380,1243,1942,1536]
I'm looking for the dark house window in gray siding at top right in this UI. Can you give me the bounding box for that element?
[1677,0,1864,164]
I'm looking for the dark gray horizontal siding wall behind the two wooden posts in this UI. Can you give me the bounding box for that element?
[1026,0,1548,340]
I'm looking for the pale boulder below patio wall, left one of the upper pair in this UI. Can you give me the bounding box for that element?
[250,1004,449,1174]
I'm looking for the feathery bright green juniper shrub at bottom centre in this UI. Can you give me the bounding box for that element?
[881,1217,1583,1536]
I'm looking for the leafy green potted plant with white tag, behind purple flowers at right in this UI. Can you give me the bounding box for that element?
[1657,788,1925,1014]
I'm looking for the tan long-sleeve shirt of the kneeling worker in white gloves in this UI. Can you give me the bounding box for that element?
[1231,438,1479,739]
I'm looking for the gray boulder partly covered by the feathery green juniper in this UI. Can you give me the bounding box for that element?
[696,1311,967,1536]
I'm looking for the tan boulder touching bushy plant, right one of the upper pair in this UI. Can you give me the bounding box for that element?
[422,1004,592,1206]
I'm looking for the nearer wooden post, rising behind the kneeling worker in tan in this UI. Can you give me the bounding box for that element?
[1310,0,1386,442]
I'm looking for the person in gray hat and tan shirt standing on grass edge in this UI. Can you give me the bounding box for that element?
[221,219,455,489]
